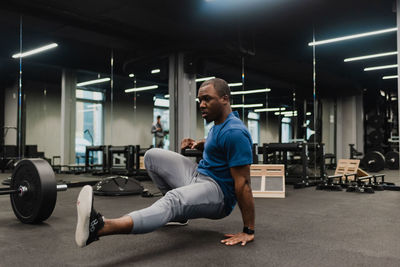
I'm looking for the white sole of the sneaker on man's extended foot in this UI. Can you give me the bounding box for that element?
[75,185,93,248]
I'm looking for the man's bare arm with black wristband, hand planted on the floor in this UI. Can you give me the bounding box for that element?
[221,165,255,246]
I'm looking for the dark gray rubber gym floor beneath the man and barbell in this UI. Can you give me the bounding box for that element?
[0,170,400,266]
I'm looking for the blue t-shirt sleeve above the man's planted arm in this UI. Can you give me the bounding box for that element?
[224,129,253,168]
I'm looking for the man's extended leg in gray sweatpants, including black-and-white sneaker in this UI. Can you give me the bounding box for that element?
[75,174,225,247]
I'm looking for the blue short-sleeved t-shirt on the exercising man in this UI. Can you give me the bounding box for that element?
[197,111,253,215]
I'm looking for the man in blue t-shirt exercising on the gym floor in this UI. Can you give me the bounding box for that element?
[75,78,255,247]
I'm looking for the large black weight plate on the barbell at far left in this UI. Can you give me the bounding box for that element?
[10,159,57,223]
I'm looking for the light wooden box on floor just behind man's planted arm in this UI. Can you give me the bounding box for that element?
[250,164,285,198]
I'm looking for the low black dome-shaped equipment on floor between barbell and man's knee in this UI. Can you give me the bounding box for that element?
[93,176,143,196]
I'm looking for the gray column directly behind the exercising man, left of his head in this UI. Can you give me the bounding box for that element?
[168,53,197,152]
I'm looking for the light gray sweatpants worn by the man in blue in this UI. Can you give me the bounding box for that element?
[129,148,226,234]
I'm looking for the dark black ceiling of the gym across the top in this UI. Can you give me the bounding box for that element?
[0,0,397,105]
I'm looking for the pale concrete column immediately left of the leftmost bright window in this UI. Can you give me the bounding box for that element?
[60,69,76,165]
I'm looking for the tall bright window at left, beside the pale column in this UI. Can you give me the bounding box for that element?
[75,89,104,164]
